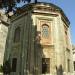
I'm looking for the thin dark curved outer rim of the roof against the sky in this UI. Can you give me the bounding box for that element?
[11,2,70,25]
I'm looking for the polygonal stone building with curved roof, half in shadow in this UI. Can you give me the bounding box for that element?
[4,3,73,75]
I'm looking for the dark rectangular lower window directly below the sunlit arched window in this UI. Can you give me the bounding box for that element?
[42,58,50,74]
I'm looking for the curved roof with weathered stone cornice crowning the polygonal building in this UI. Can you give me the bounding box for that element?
[10,2,70,25]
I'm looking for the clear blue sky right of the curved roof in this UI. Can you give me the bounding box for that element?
[17,0,75,45]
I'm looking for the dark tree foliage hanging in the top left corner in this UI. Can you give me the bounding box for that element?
[0,0,31,13]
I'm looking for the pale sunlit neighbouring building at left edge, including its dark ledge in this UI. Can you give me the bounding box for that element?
[0,10,9,65]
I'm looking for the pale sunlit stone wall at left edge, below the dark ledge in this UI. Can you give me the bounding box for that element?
[0,23,8,64]
